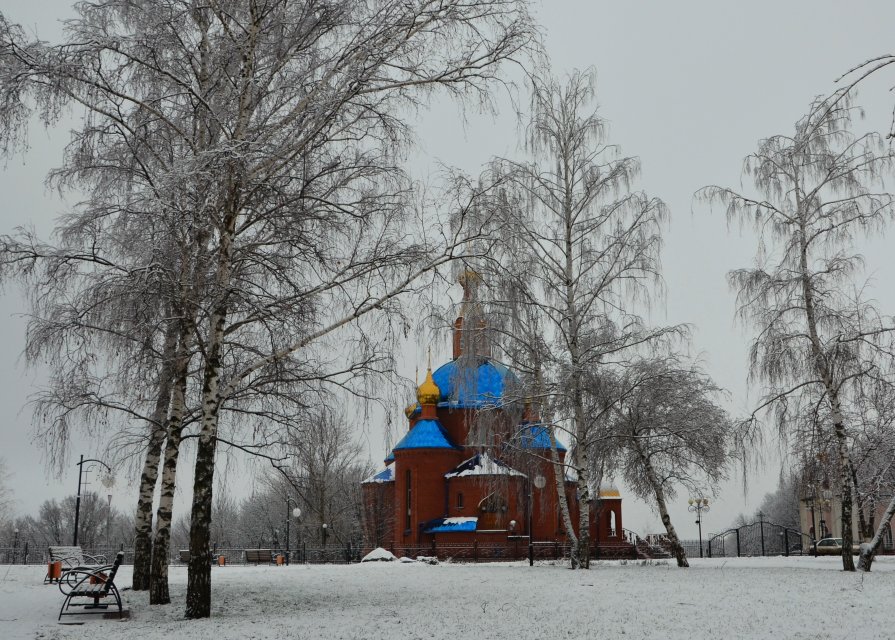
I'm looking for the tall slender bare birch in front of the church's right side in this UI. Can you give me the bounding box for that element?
[490,70,666,567]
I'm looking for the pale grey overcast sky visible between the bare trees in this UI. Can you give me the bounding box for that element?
[0,0,895,538]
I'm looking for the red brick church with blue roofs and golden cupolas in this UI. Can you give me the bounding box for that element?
[363,276,633,558]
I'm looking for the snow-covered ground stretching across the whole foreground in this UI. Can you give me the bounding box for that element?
[0,557,895,640]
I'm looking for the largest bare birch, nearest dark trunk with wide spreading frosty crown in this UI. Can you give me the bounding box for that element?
[0,0,531,618]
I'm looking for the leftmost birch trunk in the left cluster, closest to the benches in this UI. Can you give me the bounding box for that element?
[132,322,177,591]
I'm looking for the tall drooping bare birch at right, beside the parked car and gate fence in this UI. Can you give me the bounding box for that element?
[701,99,893,571]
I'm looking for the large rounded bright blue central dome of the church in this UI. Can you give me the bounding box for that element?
[432,359,519,408]
